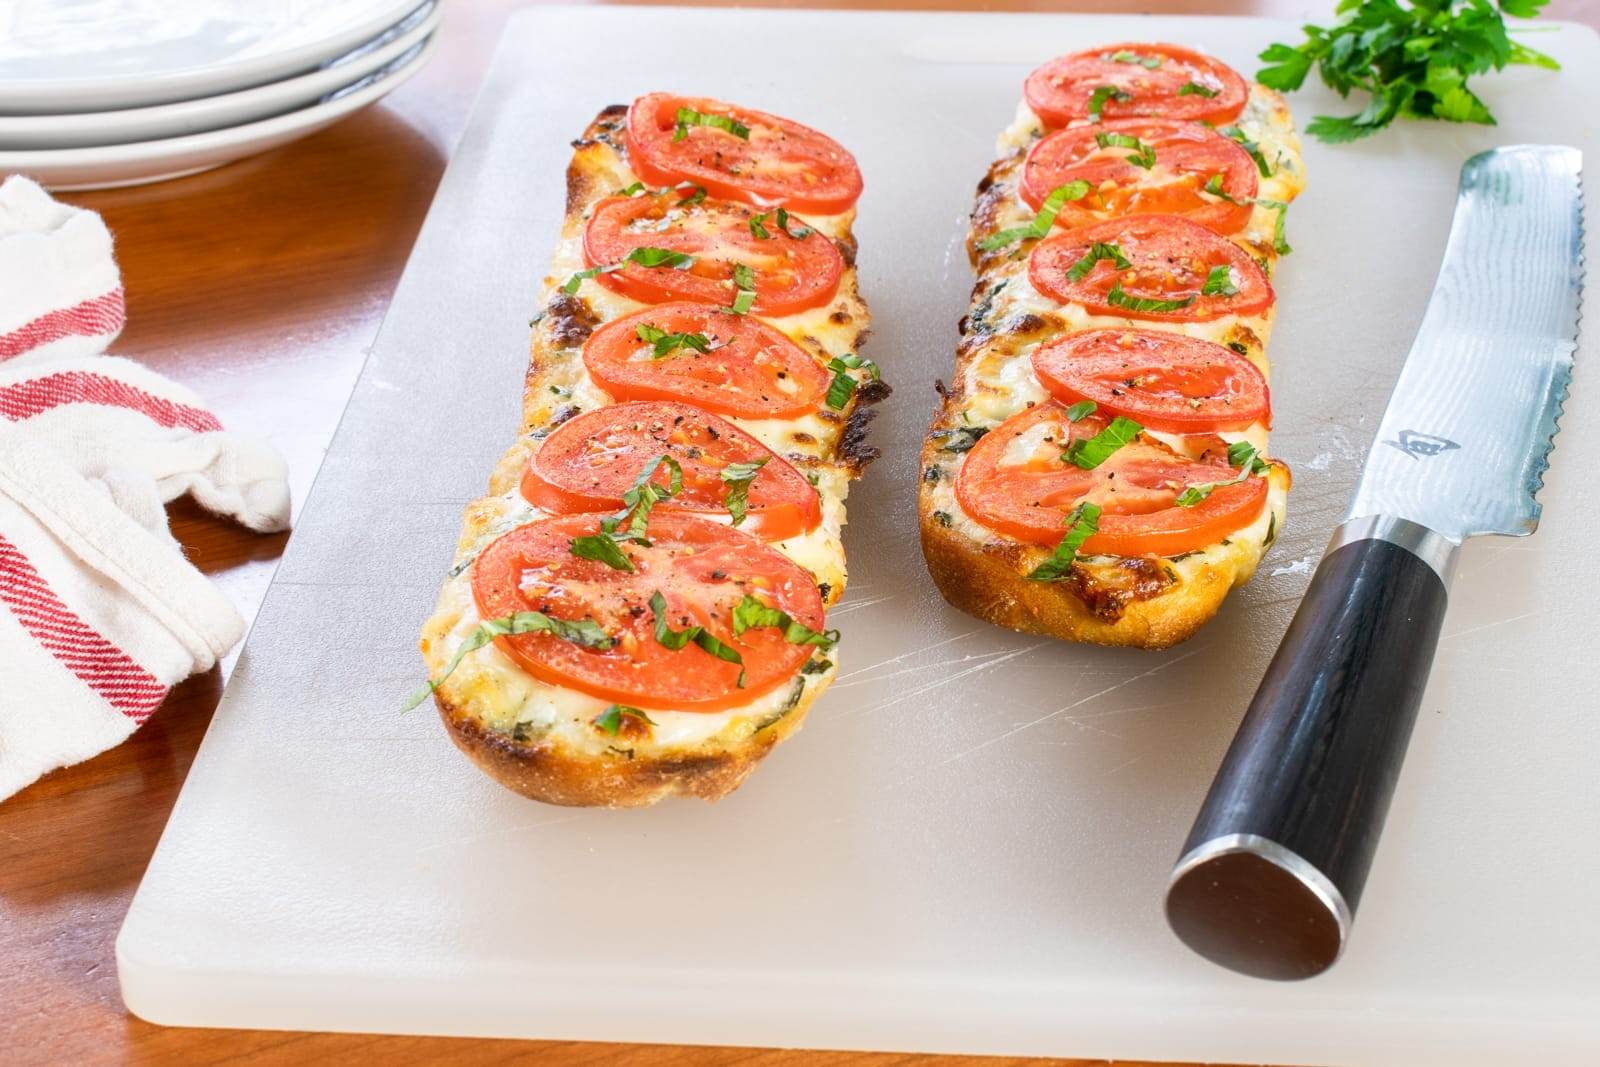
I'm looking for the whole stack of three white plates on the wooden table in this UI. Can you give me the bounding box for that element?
[0,0,443,189]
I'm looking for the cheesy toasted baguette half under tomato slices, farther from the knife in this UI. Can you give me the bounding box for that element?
[421,106,888,808]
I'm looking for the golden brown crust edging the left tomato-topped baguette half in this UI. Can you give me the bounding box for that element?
[422,106,888,808]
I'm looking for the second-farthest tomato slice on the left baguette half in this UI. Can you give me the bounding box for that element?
[584,190,845,315]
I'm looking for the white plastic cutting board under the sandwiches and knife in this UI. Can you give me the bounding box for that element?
[118,8,1600,1067]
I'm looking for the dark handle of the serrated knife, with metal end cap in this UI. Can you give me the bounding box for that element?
[1166,520,1454,979]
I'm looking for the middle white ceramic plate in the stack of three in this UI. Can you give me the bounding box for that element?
[0,3,443,152]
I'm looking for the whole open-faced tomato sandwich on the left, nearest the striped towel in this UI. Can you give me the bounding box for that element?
[422,93,888,806]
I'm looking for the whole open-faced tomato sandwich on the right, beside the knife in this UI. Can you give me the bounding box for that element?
[918,43,1304,648]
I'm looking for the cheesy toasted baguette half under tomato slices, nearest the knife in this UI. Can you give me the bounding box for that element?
[917,75,1306,648]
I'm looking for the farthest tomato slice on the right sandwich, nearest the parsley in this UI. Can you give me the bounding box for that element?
[1022,45,1250,130]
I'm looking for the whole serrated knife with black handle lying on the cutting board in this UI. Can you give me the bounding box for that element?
[1166,146,1582,979]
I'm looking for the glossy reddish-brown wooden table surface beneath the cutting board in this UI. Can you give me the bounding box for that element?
[0,0,1600,1067]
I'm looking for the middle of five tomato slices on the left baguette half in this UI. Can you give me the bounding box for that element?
[584,304,834,419]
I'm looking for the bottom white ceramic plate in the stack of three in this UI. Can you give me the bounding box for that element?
[0,37,437,189]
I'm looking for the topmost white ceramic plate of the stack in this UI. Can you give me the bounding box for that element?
[0,0,422,115]
